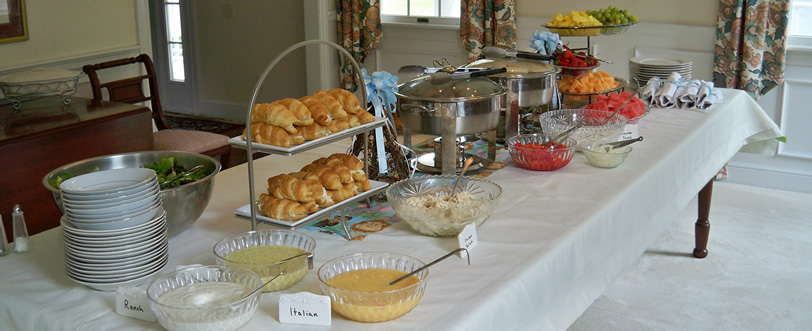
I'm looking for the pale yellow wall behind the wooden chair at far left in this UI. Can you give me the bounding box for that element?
[0,0,150,96]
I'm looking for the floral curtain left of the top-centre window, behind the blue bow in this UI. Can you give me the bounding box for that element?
[336,0,383,91]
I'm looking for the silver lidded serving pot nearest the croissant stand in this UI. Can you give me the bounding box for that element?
[396,77,507,136]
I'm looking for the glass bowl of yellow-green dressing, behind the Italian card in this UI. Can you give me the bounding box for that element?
[214,230,316,292]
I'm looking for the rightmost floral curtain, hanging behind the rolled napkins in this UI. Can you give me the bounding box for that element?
[713,0,790,100]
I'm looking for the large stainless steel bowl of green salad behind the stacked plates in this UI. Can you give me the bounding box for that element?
[42,151,221,237]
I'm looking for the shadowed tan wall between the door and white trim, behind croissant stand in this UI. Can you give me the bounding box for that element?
[193,0,307,121]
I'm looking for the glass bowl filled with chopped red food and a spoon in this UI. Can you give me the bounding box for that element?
[507,133,576,171]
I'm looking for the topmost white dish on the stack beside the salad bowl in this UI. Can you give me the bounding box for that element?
[59,168,156,195]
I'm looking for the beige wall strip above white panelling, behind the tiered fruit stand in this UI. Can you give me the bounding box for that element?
[516,0,718,26]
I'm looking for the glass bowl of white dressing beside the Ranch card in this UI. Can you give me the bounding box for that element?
[147,265,262,330]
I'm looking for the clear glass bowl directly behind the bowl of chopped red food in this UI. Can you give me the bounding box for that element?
[539,109,626,144]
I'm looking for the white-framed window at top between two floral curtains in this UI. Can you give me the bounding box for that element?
[381,0,456,25]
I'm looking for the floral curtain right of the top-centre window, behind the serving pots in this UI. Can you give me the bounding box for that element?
[460,0,516,62]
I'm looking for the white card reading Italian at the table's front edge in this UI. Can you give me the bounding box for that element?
[279,292,332,326]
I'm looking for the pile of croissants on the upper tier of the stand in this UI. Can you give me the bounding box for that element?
[243,88,375,148]
